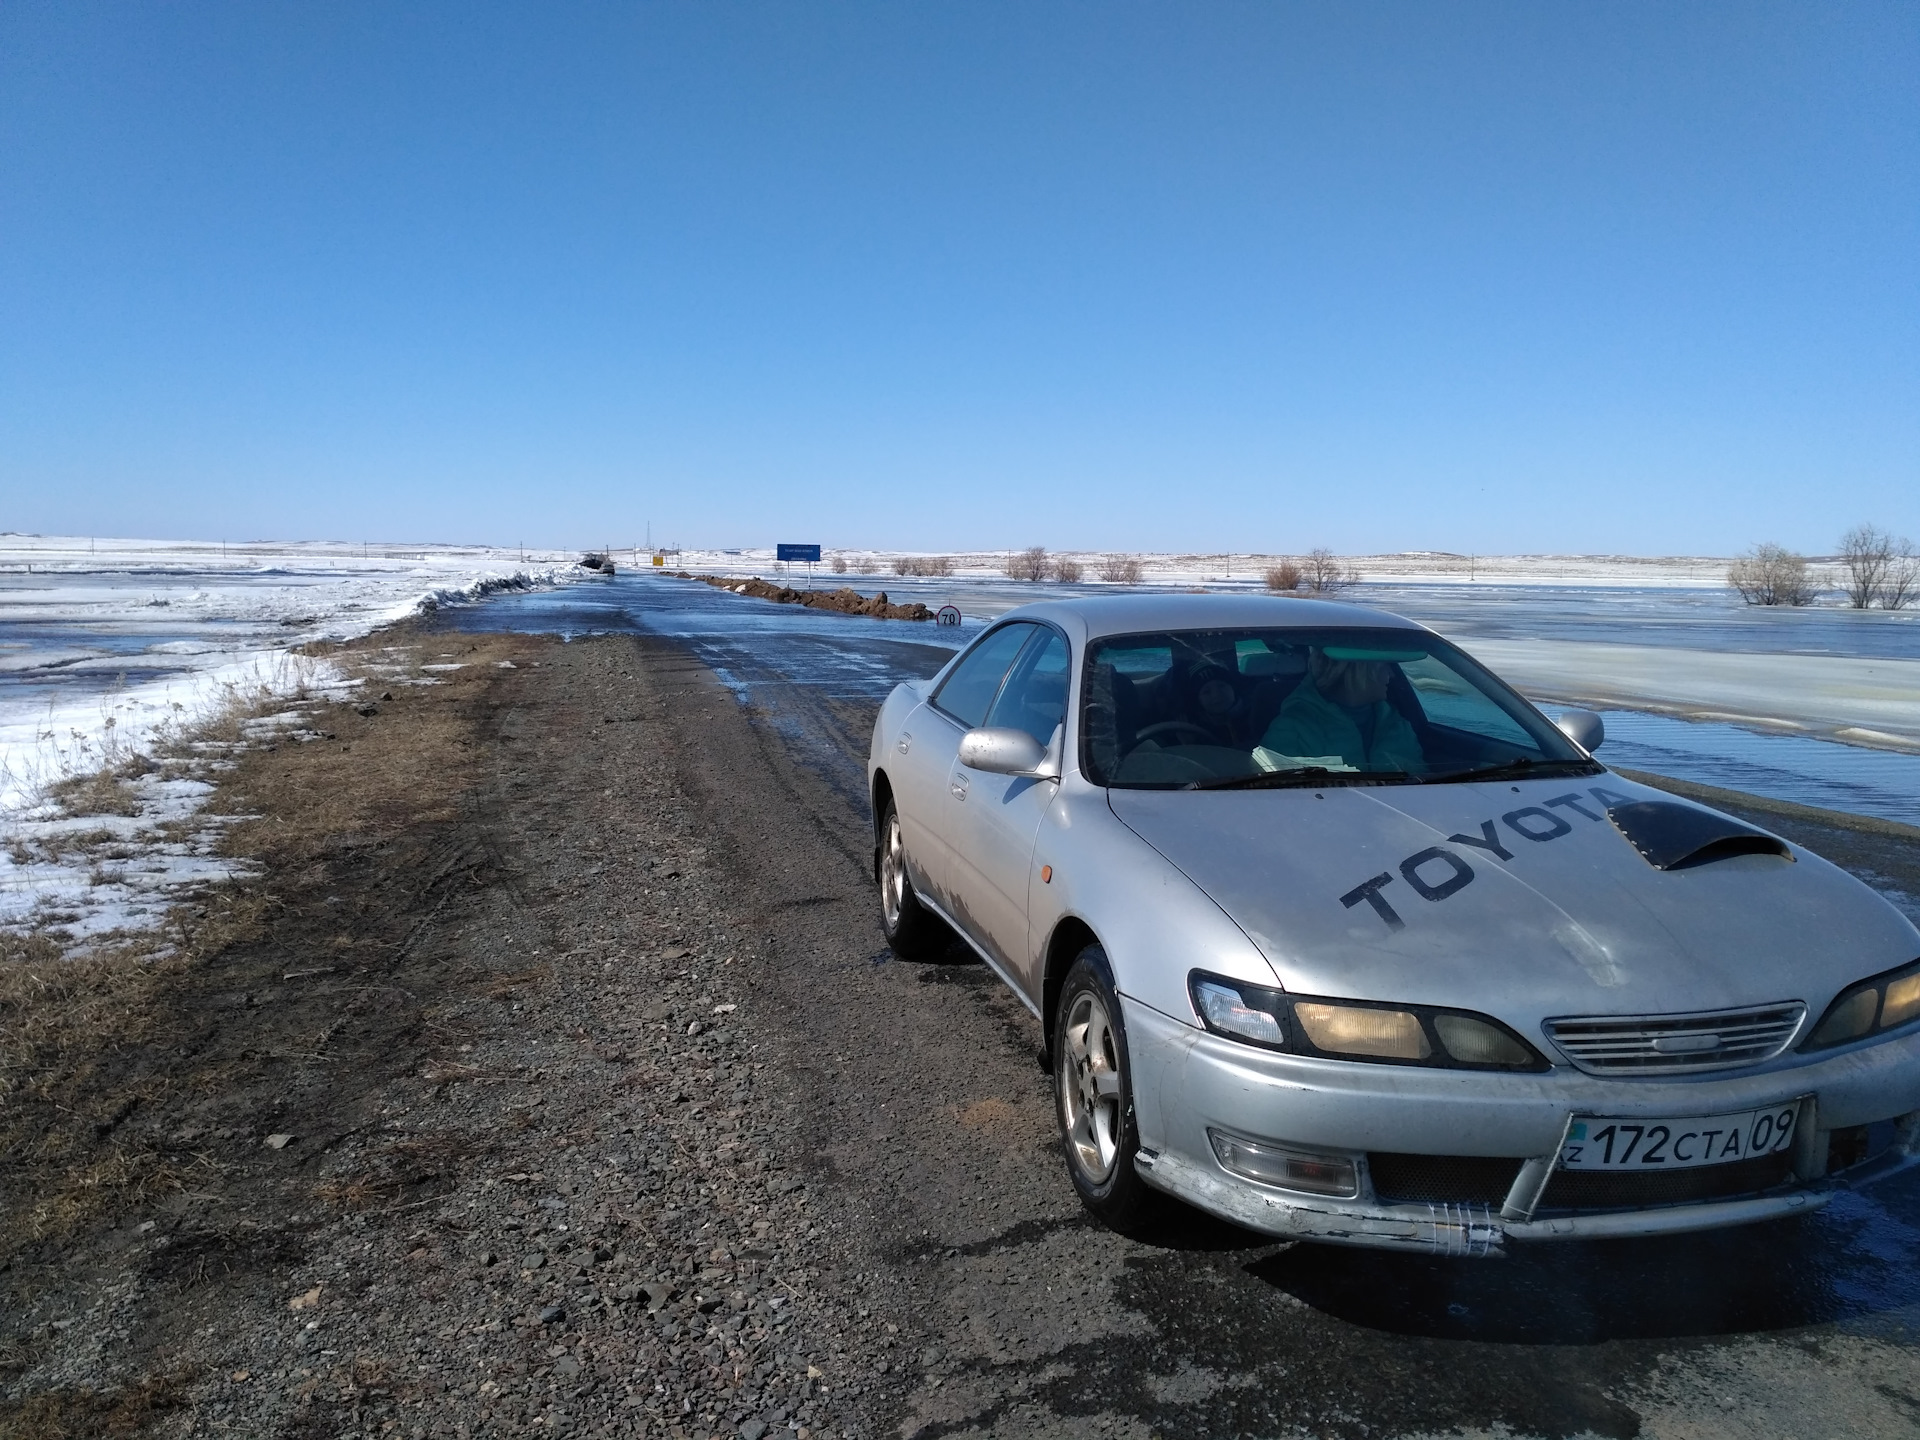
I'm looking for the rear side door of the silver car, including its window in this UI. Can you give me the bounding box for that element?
[889,622,1037,924]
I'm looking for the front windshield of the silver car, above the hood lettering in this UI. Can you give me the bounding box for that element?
[1081,630,1599,789]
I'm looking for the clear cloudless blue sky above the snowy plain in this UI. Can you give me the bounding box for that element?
[0,0,1920,555]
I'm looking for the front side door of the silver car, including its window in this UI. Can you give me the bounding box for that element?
[950,626,1068,995]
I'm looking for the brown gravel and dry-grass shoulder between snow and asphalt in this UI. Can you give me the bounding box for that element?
[0,637,913,1436]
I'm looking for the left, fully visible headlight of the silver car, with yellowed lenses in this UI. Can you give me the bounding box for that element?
[1187,968,1543,1069]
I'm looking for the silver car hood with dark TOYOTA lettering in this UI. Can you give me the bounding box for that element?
[1108,774,1920,1031]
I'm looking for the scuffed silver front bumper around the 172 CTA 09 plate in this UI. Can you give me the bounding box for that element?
[1121,996,1920,1254]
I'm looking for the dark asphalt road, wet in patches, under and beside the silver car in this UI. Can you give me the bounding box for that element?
[439,591,1920,1438]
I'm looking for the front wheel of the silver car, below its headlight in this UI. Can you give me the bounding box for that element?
[1052,945,1158,1235]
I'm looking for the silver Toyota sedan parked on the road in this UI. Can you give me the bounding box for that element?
[868,595,1920,1254]
